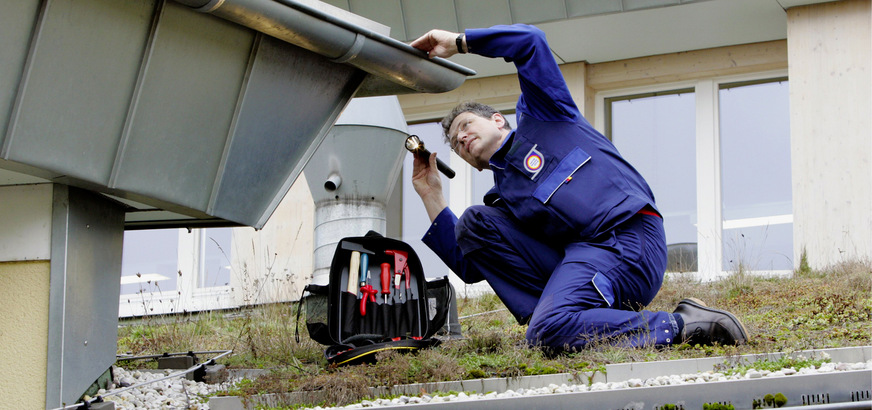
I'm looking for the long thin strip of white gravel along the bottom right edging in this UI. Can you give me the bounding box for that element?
[314,360,872,410]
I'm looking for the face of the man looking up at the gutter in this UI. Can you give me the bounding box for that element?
[448,112,508,171]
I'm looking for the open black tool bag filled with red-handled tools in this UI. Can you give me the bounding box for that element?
[297,231,452,365]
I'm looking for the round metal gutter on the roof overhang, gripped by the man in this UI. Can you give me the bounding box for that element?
[176,0,475,96]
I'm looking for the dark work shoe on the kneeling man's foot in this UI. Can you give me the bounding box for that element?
[673,298,748,345]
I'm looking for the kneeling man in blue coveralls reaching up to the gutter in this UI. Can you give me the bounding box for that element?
[411,25,747,352]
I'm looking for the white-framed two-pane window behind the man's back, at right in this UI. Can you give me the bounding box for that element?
[596,72,794,278]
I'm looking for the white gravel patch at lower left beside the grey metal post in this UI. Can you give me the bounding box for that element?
[97,367,233,410]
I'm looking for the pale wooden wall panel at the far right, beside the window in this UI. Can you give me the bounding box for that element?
[787,0,872,267]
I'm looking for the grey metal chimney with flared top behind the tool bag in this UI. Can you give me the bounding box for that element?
[304,96,407,284]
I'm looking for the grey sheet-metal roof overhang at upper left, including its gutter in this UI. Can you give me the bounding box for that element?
[0,0,475,229]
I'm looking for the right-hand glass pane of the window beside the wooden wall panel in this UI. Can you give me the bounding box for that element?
[718,81,793,271]
